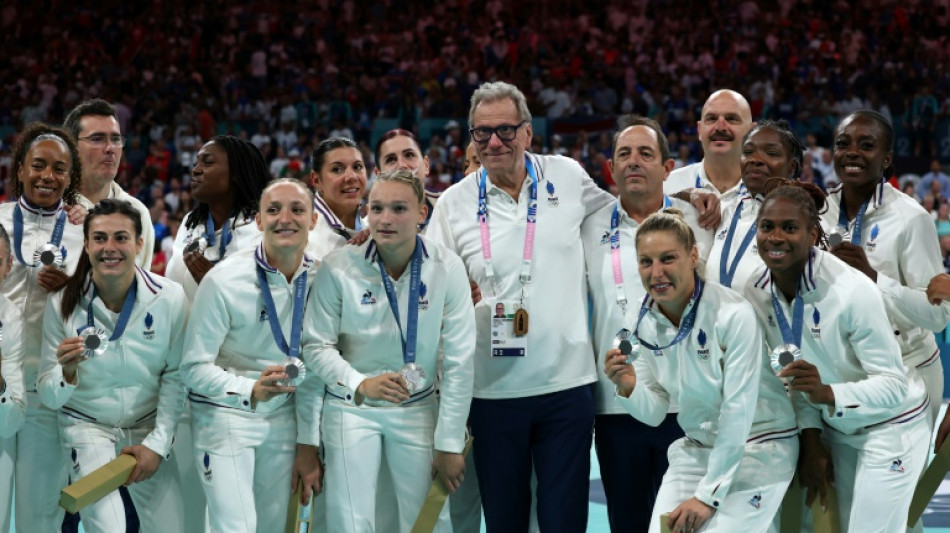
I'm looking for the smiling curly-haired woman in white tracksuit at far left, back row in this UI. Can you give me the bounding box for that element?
[0,124,82,533]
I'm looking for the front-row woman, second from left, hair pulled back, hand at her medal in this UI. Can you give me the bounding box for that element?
[182,179,323,533]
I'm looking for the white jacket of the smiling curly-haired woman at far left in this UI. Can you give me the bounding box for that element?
[0,197,83,392]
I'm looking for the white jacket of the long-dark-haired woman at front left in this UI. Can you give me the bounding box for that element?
[38,267,188,457]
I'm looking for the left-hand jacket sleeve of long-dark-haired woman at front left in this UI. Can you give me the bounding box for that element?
[36,292,82,411]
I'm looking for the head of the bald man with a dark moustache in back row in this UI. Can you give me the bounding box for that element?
[696,91,752,157]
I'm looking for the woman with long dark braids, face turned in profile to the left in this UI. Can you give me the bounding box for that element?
[165,135,270,528]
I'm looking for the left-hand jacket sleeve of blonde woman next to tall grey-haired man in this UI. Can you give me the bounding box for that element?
[301,263,367,402]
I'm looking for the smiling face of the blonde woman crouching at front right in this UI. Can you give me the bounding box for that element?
[637,230,699,314]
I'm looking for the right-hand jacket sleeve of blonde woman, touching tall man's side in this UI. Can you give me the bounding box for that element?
[435,253,475,453]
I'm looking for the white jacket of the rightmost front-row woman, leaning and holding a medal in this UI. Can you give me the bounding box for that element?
[744,248,928,448]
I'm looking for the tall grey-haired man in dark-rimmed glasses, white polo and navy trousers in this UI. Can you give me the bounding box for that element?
[427,82,613,533]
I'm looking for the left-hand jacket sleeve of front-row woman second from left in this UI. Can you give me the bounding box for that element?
[181,275,256,411]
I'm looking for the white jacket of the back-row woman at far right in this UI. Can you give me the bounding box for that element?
[821,181,950,367]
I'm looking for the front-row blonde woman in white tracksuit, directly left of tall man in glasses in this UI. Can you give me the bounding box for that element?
[304,171,475,533]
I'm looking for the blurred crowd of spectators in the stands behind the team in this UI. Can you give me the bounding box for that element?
[0,0,950,270]
